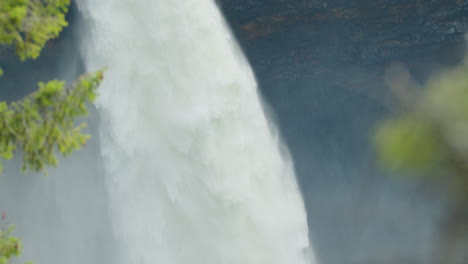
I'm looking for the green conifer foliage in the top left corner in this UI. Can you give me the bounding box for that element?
[0,0,70,60]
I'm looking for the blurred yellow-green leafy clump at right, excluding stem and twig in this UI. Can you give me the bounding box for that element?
[374,64,468,180]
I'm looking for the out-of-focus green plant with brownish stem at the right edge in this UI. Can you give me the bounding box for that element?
[375,59,468,264]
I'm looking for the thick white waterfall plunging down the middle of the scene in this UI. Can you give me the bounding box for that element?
[78,0,315,264]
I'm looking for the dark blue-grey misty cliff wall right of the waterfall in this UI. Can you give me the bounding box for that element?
[218,0,468,264]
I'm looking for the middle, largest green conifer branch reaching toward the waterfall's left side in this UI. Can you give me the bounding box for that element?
[0,71,103,171]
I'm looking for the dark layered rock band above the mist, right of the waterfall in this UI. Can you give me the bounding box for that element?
[219,0,468,77]
